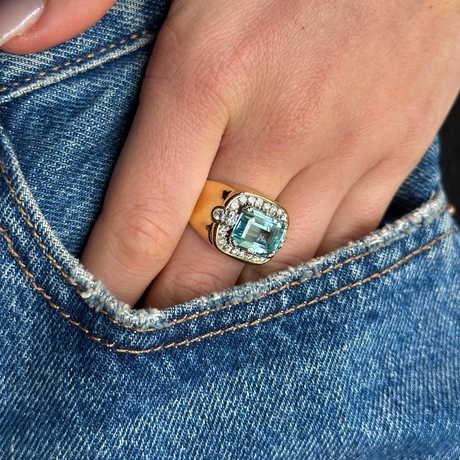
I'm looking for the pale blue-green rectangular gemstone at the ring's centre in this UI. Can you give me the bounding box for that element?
[232,209,285,256]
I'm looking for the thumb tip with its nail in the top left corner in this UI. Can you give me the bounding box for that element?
[0,0,115,54]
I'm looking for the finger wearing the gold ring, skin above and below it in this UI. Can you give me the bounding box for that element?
[145,136,298,309]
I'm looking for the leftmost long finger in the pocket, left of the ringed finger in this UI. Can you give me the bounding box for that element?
[82,30,227,305]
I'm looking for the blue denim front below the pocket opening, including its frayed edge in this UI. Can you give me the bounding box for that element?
[0,126,460,459]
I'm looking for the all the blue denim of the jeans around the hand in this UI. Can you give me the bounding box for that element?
[0,0,460,460]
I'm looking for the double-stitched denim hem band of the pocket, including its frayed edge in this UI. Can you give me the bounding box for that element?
[0,126,456,348]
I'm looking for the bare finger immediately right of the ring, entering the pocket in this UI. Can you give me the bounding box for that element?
[238,157,367,283]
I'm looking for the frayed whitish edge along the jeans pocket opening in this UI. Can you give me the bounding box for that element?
[0,119,445,329]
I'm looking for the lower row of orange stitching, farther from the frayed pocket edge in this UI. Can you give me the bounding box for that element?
[0,226,455,355]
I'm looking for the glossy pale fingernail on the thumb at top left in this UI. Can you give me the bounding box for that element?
[0,0,45,46]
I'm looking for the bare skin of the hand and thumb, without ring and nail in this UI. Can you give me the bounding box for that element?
[3,0,460,308]
